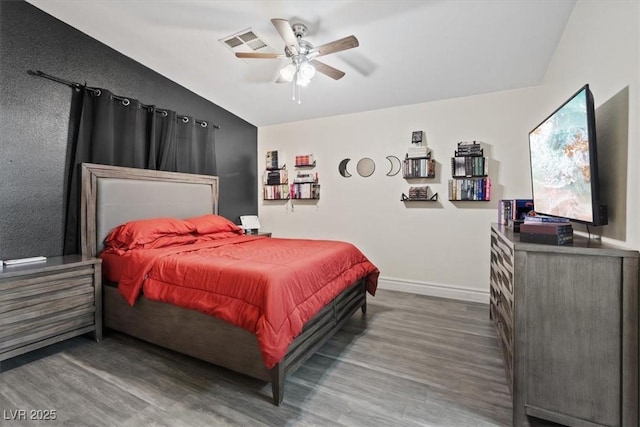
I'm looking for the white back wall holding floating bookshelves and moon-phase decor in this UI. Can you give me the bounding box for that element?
[258,89,541,301]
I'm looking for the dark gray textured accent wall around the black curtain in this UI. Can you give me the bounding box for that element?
[0,0,258,259]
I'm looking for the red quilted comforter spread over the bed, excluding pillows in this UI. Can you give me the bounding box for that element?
[103,236,379,369]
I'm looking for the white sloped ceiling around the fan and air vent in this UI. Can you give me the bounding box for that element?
[27,0,575,126]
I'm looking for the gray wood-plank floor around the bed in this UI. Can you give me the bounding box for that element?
[0,290,511,427]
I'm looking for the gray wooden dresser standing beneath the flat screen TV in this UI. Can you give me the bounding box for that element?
[490,224,640,427]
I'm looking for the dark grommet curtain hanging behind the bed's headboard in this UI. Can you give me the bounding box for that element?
[64,87,216,254]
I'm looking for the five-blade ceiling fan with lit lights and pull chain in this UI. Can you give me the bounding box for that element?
[236,18,359,103]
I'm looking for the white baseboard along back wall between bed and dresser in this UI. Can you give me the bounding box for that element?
[378,277,489,304]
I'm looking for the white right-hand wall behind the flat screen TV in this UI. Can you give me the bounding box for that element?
[541,0,640,249]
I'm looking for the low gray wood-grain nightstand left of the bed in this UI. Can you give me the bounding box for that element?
[0,255,102,370]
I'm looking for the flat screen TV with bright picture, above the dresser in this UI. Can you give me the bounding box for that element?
[529,84,608,225]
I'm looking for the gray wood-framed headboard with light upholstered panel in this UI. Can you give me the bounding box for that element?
[80,163,218,256]
